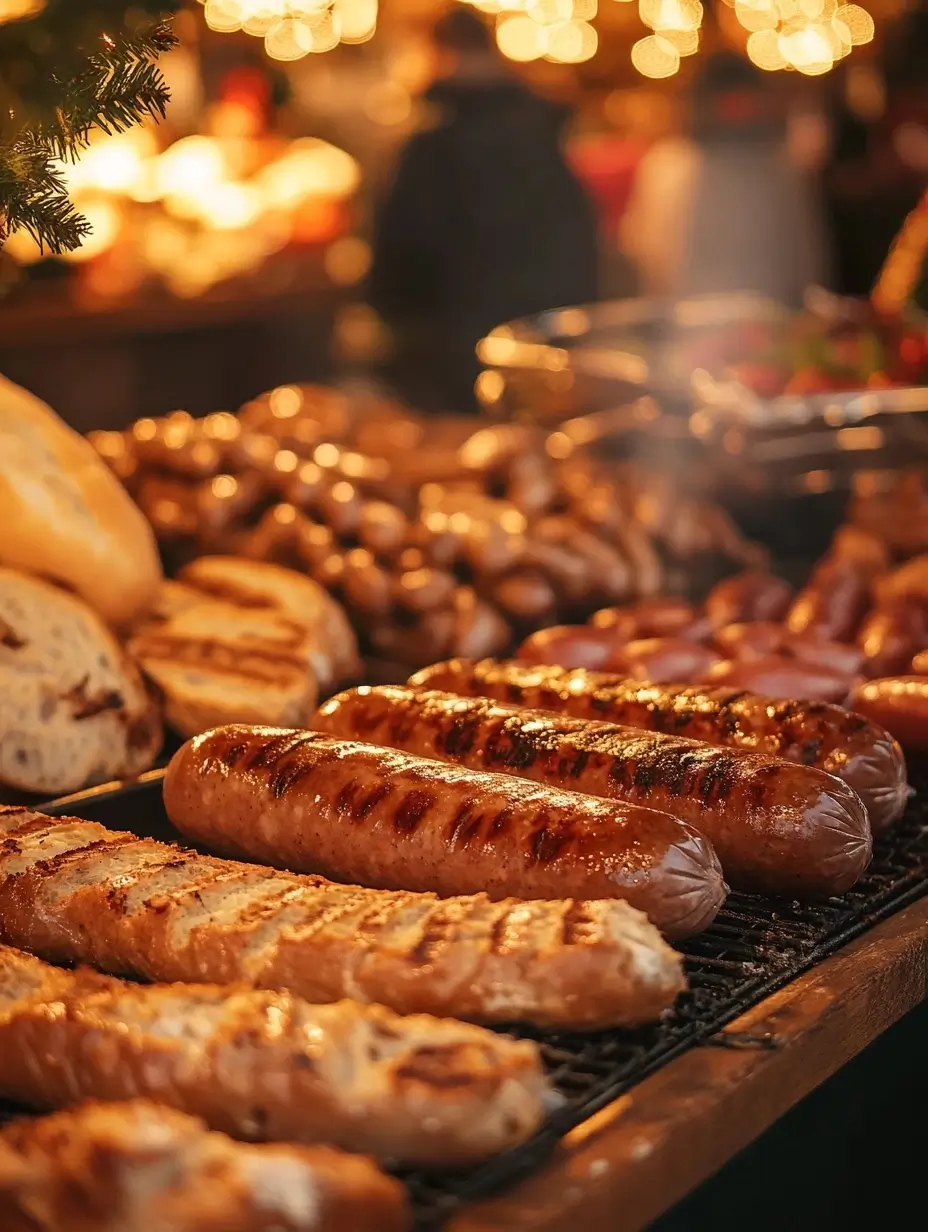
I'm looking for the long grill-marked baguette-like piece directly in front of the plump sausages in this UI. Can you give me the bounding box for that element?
[0,808,684,1029]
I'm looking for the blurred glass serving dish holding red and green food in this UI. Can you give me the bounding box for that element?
[478,292,928,499]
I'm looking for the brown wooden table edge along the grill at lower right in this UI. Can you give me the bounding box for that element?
[447,898,928,1232]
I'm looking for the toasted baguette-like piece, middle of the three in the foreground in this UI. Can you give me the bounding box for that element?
[0,946,546,1165]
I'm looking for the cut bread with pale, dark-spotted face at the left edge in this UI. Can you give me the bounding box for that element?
[0,568,163,796]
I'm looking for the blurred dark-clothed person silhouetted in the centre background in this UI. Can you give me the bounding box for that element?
[370,5,598,413]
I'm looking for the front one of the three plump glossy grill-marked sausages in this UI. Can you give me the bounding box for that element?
[164,724,725,936]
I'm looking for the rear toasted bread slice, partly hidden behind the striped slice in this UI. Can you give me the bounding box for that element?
[177,556,360,692]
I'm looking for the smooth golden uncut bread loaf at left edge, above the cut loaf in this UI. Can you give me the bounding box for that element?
[0,377,161,626]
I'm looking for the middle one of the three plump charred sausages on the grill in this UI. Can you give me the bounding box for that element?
[315,686,870,898]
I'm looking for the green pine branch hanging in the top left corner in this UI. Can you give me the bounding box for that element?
[0,0,179,253]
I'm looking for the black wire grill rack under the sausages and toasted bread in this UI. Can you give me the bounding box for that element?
[21,760,928,1232]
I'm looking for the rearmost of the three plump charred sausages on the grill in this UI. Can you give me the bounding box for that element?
[409,659,908,832]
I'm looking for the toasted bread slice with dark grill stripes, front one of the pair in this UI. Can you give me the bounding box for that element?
[129,599,319,736]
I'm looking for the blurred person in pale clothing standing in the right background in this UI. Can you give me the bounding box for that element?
[620,52,828,306]
